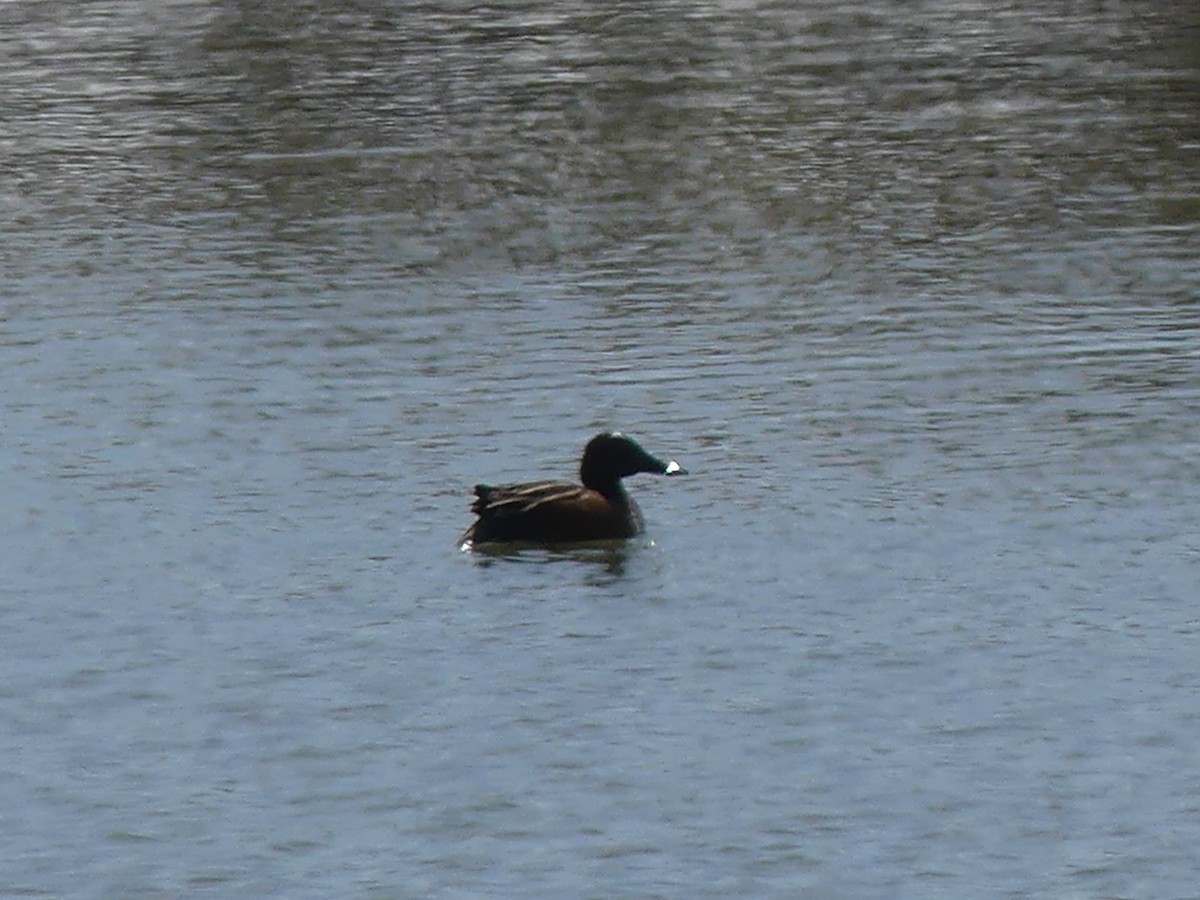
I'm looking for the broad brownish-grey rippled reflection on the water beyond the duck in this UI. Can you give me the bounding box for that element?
[2,2,1200,283]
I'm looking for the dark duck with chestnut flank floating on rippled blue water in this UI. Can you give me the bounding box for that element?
[460,431,688,548]
